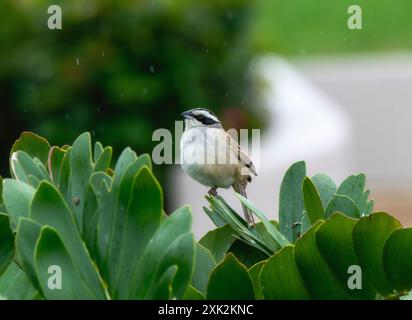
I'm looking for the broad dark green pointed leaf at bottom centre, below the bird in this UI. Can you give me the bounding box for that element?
[207,253,255,300]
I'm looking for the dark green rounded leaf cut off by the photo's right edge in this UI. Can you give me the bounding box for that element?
[383,228,412,292]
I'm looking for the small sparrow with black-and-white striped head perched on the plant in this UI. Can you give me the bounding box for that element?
[180,108,257,226]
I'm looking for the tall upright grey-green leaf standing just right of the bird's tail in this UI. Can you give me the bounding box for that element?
[279,161,306,242]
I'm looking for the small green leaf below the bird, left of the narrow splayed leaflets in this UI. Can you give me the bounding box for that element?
[199,224,236,263]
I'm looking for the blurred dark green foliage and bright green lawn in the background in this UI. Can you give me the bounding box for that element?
[0,0,412,177]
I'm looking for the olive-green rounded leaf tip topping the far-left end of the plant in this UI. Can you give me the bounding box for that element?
[10,132,50,167]
